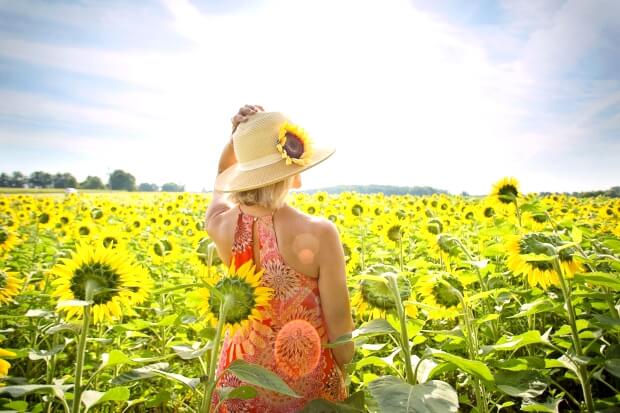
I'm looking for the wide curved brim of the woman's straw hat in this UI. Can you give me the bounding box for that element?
[215,147,336,192]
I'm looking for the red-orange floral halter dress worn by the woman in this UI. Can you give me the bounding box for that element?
[214,211,346,413]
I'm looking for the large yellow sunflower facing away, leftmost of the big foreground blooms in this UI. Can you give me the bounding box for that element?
[52,244,153,323]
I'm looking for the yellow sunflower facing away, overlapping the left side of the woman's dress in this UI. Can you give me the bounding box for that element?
[189,260,273,334]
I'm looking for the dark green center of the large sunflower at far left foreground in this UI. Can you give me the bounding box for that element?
[71,262,121,304]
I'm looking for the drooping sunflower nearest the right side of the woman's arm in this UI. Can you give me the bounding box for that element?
[351,264,418,319]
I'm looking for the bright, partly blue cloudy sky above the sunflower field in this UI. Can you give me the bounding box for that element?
[0,0,620,194]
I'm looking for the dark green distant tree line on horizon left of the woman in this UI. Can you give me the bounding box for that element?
[0,169,185,192]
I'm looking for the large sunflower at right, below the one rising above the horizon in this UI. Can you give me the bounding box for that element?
[506,232,583,288]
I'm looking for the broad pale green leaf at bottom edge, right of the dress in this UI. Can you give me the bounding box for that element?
[368,376,459,413]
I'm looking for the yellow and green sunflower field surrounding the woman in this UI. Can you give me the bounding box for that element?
[0,178,620,413]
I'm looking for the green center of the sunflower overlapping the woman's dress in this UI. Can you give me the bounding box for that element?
[209,277,256,324]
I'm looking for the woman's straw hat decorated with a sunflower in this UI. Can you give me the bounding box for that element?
[215,112,335,192]
